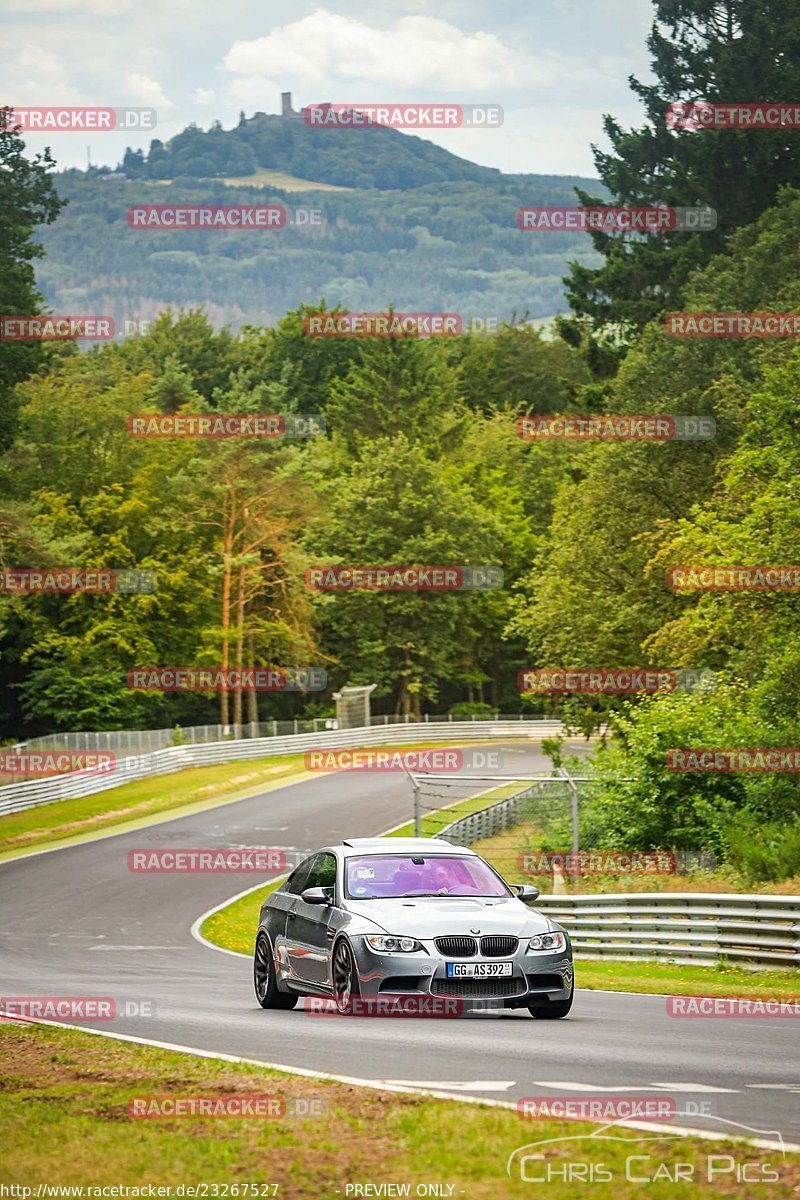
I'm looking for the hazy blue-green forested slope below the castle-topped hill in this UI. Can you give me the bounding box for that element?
[38,170,600,329]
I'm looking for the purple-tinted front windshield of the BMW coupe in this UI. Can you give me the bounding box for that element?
[345,854,509,900]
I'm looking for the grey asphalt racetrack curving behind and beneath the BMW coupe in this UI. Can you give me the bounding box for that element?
[0,742,800,1145]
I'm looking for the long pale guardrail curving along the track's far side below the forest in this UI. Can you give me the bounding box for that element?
[0,720,563,816]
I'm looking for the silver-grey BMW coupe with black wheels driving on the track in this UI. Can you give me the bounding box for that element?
[254,838,573,1019]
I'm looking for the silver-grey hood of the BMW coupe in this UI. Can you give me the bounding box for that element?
[347,896,555,938]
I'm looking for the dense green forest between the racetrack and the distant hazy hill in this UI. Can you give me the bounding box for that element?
[0,0,800,878]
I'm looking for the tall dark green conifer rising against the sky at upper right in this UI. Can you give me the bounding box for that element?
[567,0,800,331]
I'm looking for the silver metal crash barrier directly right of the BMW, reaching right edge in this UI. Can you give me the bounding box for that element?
[535,892,800,967]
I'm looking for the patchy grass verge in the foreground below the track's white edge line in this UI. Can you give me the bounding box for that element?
[0,1013,800,1200]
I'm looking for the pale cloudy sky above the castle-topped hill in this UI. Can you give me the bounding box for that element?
[0,0,652,174]
